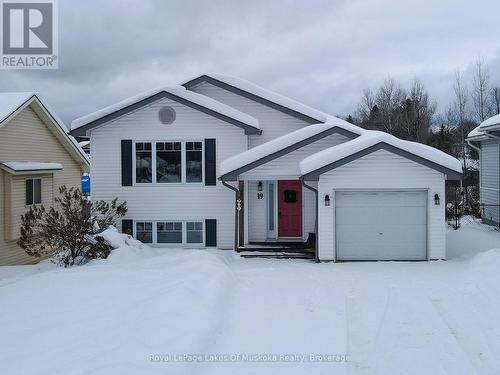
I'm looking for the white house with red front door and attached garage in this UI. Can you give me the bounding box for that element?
[72,75,461,260]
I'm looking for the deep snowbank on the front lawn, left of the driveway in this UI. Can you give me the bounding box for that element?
[0,229,234,375]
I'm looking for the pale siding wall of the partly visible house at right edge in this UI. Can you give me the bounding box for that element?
[480,139,500,223]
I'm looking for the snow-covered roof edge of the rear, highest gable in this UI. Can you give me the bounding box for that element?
[184,73,328,122]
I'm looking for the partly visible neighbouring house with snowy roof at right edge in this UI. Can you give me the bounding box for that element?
[467,115,500,225]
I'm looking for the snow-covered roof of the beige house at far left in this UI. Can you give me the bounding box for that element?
[0,92,90,165]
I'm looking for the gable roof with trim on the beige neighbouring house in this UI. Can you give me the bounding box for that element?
[0,92,90,166]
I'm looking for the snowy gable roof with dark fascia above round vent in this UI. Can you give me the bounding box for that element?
[71,86,261,136]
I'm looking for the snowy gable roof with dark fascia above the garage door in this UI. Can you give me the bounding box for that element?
[300,130,462,179]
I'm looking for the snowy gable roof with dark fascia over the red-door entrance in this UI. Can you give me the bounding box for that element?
[220,116,364,181]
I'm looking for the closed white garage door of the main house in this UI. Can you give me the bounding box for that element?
[335,191,427,260]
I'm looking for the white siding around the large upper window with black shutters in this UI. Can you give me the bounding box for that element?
[91,98,247,248]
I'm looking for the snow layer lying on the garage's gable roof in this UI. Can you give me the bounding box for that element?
[300,130,462,175]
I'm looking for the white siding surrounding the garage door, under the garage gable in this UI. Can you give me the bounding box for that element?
[319,150,446,260]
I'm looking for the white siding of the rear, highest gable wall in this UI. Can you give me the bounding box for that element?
[190,82,312,149]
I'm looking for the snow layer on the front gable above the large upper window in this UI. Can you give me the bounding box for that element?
[71,85,260,130]
